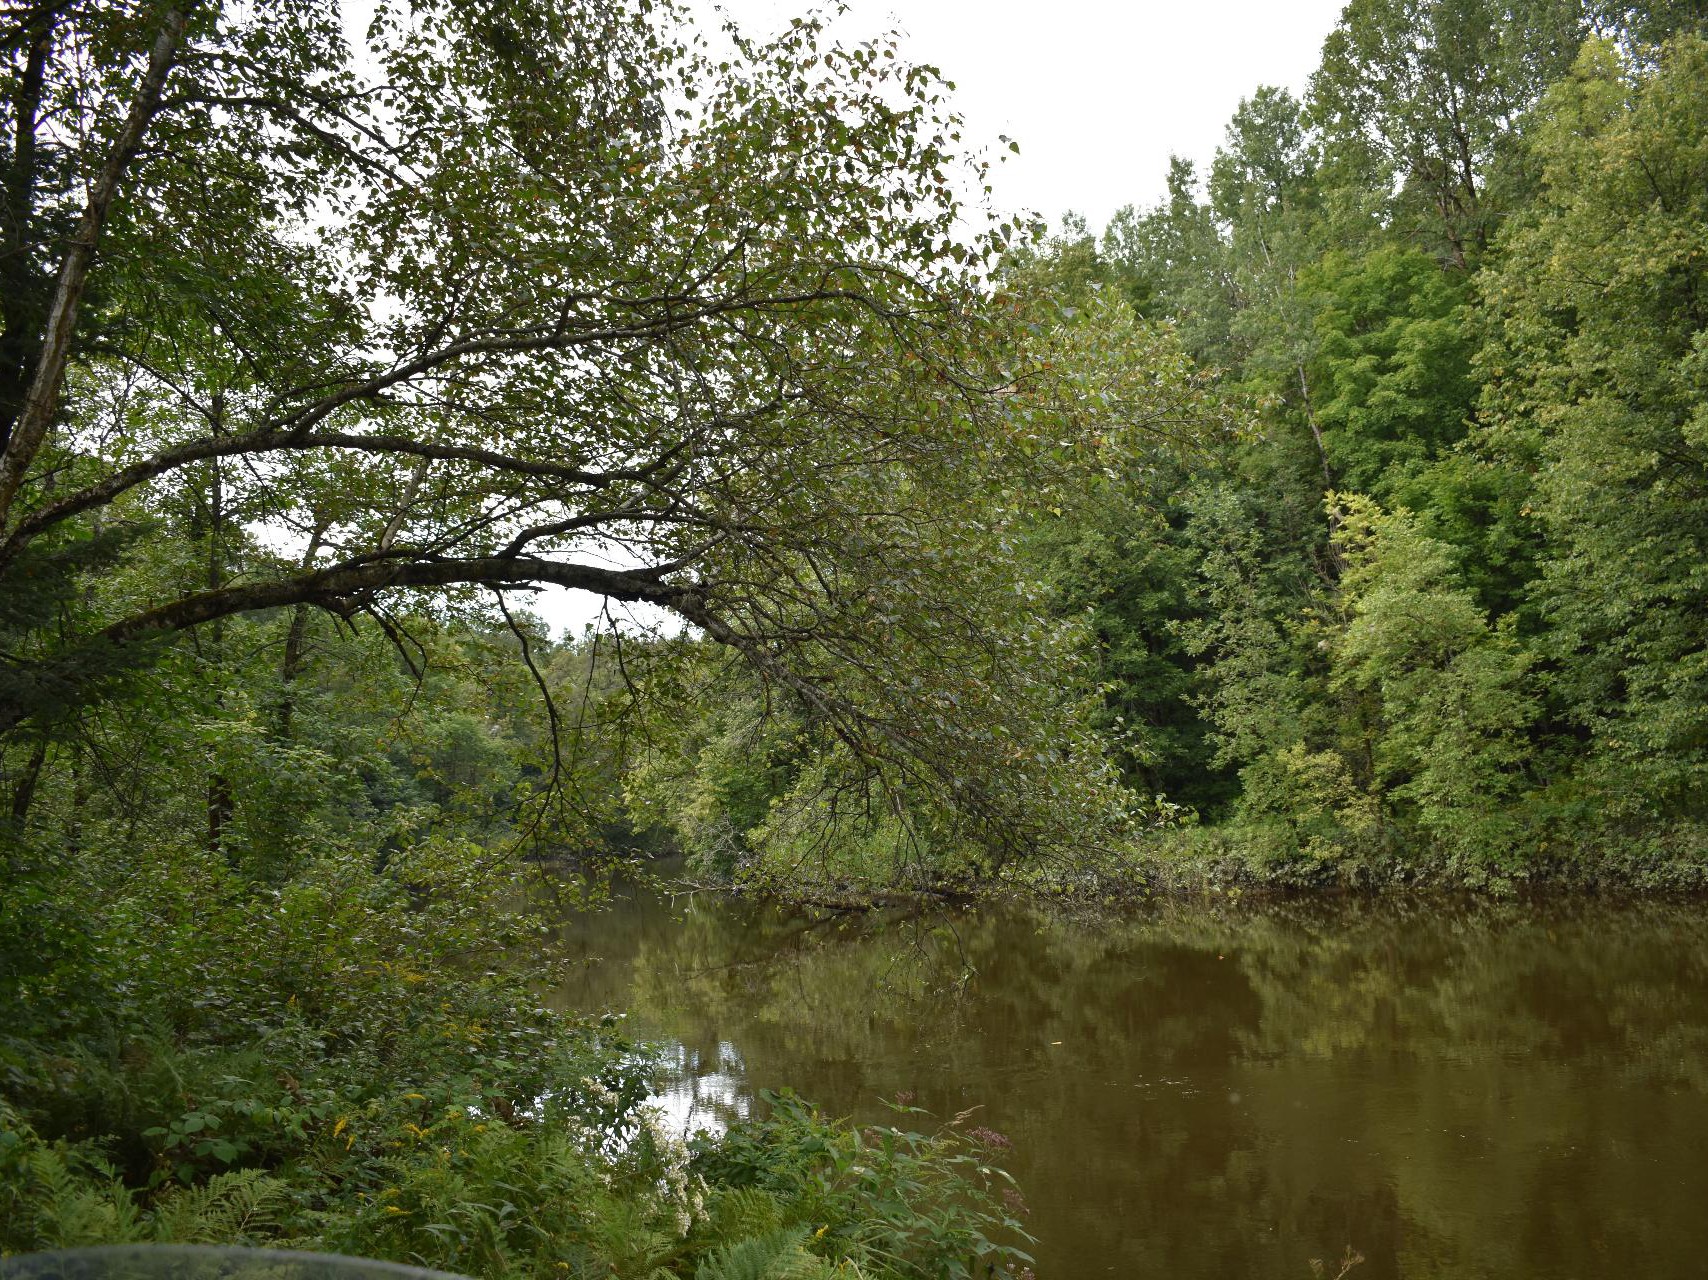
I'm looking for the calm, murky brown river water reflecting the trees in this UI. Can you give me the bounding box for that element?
[546,890,1708,1280]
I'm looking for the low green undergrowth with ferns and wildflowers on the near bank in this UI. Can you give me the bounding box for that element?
[0,823,1020,1277]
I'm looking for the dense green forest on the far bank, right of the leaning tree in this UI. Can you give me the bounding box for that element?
[638,3,1708,885]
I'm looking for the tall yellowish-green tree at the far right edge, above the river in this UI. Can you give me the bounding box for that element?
[1483,38,1708,822]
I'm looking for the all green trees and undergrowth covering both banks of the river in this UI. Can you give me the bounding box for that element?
[0,0,1708,1277]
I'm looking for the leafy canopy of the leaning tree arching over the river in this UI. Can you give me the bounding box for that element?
[0,0,1195,868]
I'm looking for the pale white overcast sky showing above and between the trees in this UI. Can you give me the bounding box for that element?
[535,0,1344,632]
